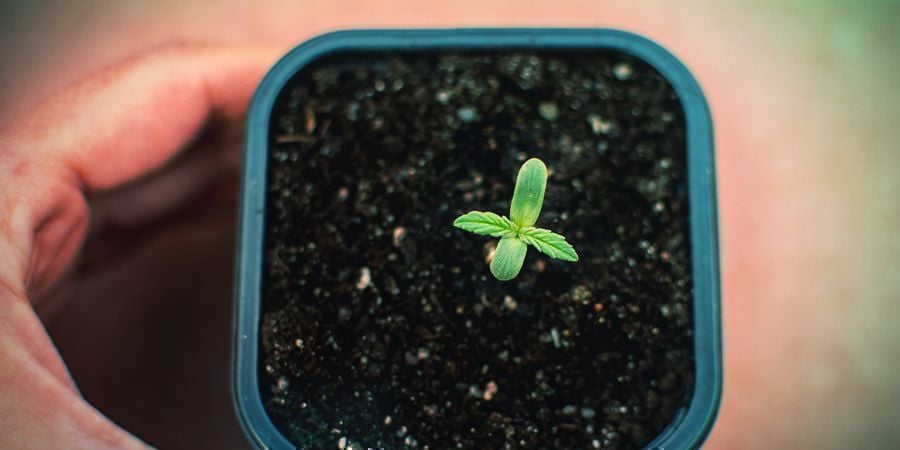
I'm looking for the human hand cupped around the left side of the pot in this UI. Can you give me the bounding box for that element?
[0,46,276,449]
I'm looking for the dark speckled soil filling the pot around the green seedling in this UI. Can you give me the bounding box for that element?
[260,53,693,449]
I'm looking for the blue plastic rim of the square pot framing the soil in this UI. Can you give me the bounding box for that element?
[232,29,722,449]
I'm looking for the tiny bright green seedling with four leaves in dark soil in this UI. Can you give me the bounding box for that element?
[453,158,578,281]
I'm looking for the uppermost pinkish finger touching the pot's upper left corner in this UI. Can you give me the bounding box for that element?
[7,46,276,191]
